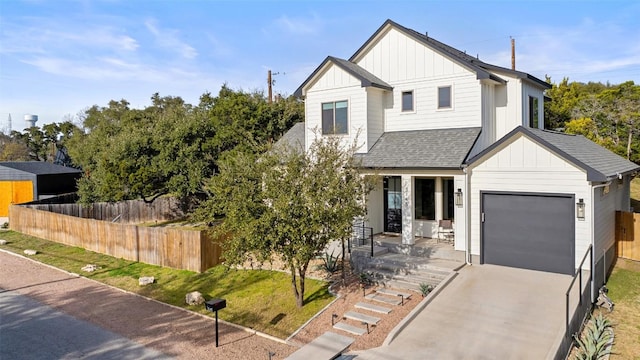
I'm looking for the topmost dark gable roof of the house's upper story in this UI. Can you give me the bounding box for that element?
[349,19,551,89]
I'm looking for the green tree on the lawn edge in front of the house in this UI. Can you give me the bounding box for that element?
[198,137,372,307]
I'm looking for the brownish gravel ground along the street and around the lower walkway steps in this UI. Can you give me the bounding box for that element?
[0,251,421,360]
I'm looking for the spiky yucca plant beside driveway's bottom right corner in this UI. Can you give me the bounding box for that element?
[573,314,612,360]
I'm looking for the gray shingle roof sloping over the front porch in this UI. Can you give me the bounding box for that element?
[359,128,480,169]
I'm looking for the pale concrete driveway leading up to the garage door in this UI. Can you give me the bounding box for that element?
[357,265,571,360]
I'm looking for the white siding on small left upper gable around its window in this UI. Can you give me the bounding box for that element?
[305,65,369,151]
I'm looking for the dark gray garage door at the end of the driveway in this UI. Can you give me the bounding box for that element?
[481,193,575,274]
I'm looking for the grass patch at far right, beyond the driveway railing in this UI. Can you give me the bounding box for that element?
[603,258,640,359]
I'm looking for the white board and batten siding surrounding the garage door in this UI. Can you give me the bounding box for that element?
[468,136,593,266]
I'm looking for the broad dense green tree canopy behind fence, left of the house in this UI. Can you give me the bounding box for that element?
[68,85,303,203]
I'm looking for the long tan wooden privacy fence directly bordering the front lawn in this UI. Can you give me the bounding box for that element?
[9,205,221,272]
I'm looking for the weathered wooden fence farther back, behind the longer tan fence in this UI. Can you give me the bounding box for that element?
[23,197,184,224]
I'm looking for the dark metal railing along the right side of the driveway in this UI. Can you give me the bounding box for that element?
[555,245,593,359]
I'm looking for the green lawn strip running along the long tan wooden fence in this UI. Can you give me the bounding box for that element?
[1,231,333,338]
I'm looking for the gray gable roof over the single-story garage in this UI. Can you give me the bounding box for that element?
[467,126,640,182]
